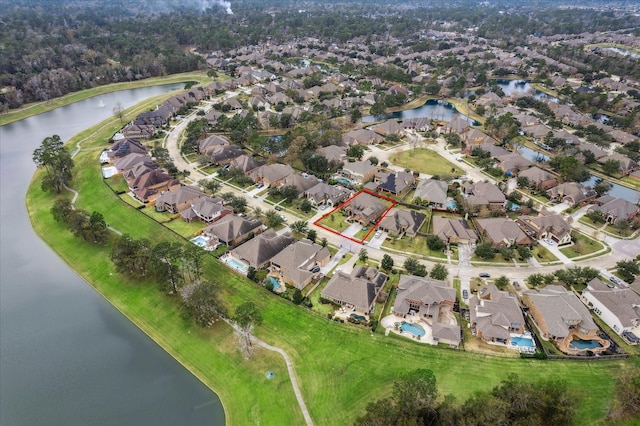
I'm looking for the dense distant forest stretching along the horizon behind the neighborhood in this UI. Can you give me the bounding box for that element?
[0,0,640,112]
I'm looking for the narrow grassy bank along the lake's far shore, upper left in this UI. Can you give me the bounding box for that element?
[0,72,211,126]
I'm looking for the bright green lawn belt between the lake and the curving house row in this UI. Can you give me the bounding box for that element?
[27,85,638,425]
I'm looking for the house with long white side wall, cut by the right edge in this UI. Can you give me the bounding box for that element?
[582,278,640,339]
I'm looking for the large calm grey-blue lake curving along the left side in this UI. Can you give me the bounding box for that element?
[0,84,225,425]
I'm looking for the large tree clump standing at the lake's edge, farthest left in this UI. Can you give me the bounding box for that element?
[33,135,73,194]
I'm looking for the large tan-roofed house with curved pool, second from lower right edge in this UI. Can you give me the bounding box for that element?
[522,285,598,344]
